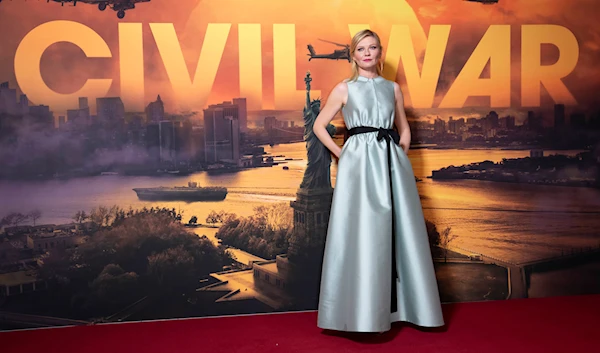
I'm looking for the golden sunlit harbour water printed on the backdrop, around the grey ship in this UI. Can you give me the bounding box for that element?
[0,143,600,262]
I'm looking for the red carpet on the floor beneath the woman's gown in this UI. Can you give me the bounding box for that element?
[0,295,600,353]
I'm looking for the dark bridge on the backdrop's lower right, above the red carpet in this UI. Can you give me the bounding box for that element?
[449,245,600,299]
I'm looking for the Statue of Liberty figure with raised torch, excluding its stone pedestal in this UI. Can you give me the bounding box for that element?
[300,72,335,189]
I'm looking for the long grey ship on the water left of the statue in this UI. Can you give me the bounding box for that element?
[133,181,227,201]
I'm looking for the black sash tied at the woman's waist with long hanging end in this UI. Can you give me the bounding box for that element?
[348,126,400,313]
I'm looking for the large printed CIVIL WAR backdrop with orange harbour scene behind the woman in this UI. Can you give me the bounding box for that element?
[0,0,600,330]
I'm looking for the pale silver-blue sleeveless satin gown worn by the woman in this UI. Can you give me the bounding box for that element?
[317,76,444,332]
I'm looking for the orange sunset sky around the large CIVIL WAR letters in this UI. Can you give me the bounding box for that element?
[0,0,600,119]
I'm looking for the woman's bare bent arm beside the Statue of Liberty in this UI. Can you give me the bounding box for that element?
[313,82,348,158]
